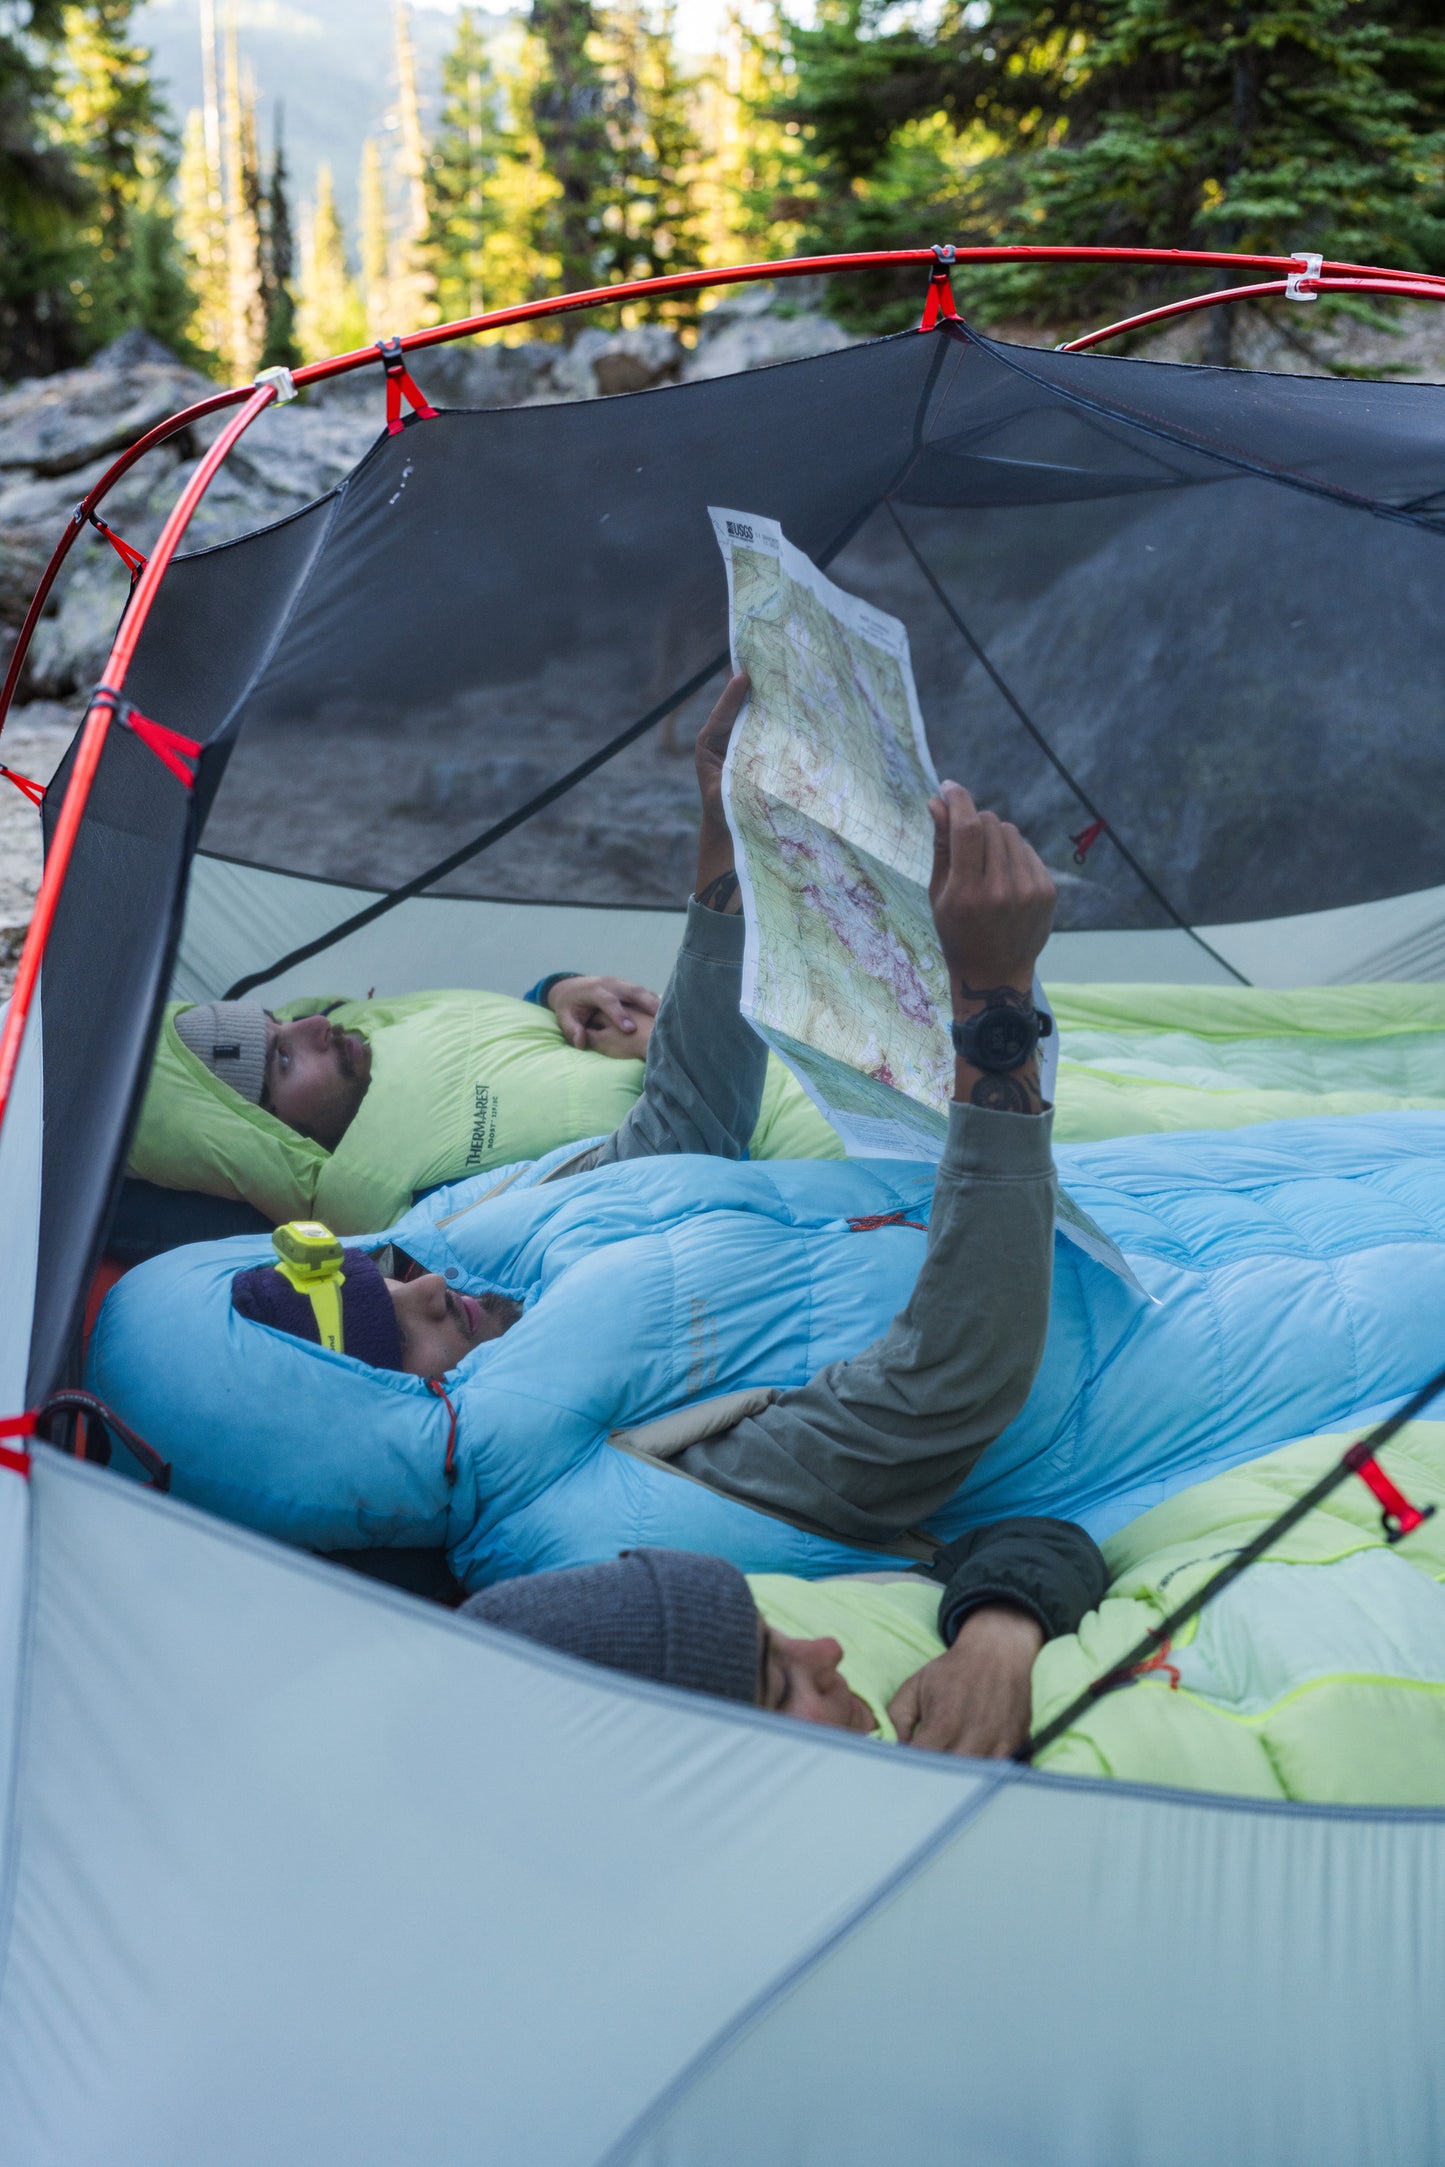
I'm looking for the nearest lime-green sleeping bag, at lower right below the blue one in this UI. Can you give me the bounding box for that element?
[750,1422,1445,1805]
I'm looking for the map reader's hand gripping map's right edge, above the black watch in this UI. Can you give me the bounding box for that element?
[927,782,1055,996]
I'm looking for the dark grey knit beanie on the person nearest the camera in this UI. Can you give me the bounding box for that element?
[459,1549,758,1708]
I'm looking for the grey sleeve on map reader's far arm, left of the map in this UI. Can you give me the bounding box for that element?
[596,901,767,1166]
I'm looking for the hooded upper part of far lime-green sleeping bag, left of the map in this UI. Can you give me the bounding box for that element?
[130,992,843,1233]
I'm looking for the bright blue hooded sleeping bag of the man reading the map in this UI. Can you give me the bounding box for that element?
[87,1114,1445,1588]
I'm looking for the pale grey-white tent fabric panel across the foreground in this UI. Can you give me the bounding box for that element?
[0,1439,1445,2167]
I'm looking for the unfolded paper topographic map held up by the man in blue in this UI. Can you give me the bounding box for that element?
[708,507,1144,1292]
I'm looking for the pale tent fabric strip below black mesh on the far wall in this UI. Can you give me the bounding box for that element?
[171,852,1445,1001]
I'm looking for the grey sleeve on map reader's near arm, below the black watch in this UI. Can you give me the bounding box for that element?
[674,1105,1053,1545]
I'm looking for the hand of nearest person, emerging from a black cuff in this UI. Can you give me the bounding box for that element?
[888,1604,1044,1760]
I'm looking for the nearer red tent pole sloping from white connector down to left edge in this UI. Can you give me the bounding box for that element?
[0,384,275,1127]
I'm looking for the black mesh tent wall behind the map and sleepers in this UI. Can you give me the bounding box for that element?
[2,266,1445,1402]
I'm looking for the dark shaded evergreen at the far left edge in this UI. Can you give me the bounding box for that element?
[0,0,87,377]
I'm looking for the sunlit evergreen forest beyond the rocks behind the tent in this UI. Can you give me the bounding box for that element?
[0,0,1445,381]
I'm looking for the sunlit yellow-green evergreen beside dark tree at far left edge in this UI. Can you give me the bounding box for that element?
[58,0,195,349]
